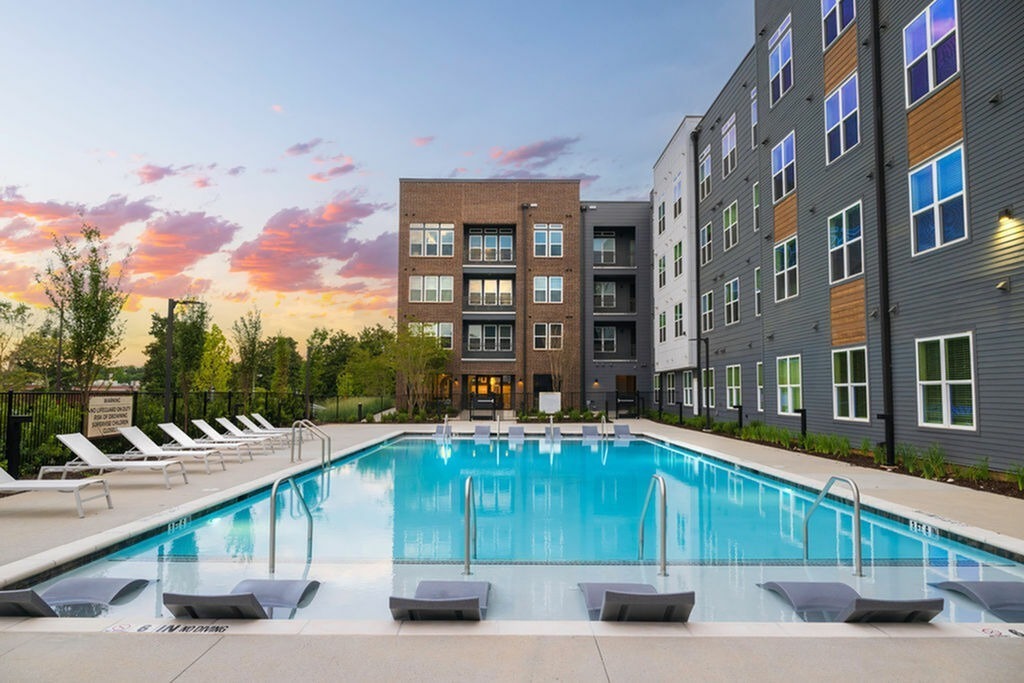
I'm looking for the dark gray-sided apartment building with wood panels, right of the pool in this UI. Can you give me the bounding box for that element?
[655,0,1024,469]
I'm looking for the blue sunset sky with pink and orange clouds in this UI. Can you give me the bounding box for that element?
[0,0,754,364]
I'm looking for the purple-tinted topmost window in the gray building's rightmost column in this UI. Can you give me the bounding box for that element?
[903,0,959,106]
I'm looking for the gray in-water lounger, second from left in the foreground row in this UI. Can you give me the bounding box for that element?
[164,579,319,618]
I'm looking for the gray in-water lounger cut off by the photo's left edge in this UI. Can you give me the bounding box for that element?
[0,578,150,616]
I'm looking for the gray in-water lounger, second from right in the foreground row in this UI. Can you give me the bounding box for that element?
[758,581,945,624]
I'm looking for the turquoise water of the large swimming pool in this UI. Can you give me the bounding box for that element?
[36,438,1024,621]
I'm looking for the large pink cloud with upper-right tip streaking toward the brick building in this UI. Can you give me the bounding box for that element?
[231,193,387,292]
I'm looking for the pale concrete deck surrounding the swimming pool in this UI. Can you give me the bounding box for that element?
[0,420,1024,681]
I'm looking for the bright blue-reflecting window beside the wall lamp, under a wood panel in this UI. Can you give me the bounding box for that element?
[910,147,967,254]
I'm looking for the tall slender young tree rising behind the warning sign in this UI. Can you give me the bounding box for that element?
[36,222,130,392]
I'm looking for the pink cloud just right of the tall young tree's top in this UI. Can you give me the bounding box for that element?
[131,212,240,278]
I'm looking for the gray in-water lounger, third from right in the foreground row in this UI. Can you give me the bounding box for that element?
[580,583,694,623]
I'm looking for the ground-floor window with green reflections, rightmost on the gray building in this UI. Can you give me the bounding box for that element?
[918,334,975,429]
